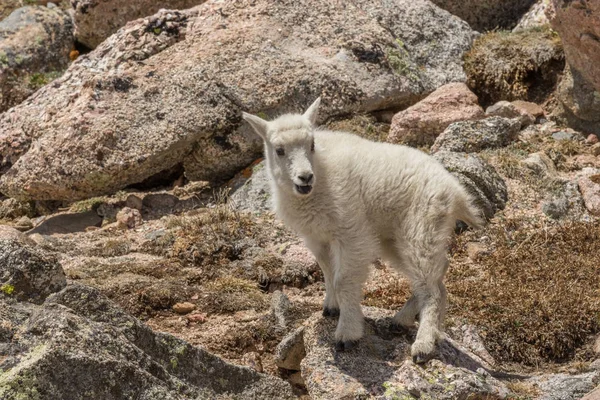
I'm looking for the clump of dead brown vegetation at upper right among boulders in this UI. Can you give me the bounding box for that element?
[465,27,565,106]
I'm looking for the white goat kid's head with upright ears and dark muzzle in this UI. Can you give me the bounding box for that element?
[243,98,321,196]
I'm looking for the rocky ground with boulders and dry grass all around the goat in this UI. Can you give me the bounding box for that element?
[0,0,600,400]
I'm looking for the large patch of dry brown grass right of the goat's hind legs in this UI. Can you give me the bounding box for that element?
[447,220,600,365]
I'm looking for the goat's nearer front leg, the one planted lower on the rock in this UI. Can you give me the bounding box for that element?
[332,242,371,351]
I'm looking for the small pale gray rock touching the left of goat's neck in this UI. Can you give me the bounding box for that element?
[229,161,272,213]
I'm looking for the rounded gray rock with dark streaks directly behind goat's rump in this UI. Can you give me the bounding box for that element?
[433,151,508,218]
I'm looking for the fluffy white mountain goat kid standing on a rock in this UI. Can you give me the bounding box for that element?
[243,98,482,363]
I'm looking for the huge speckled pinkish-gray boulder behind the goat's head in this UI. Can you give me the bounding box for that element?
[0,0,474,200]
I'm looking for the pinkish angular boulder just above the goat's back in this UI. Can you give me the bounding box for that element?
[388,83,485,146]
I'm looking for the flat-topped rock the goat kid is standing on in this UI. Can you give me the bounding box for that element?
[301,307,509,400]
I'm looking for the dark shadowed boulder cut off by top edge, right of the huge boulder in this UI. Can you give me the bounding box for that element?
[432,0,535,32]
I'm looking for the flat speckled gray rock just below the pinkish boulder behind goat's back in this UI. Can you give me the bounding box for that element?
[431,117,521,153]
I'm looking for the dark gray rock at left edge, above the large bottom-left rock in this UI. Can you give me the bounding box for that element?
[0,228,67,304]
